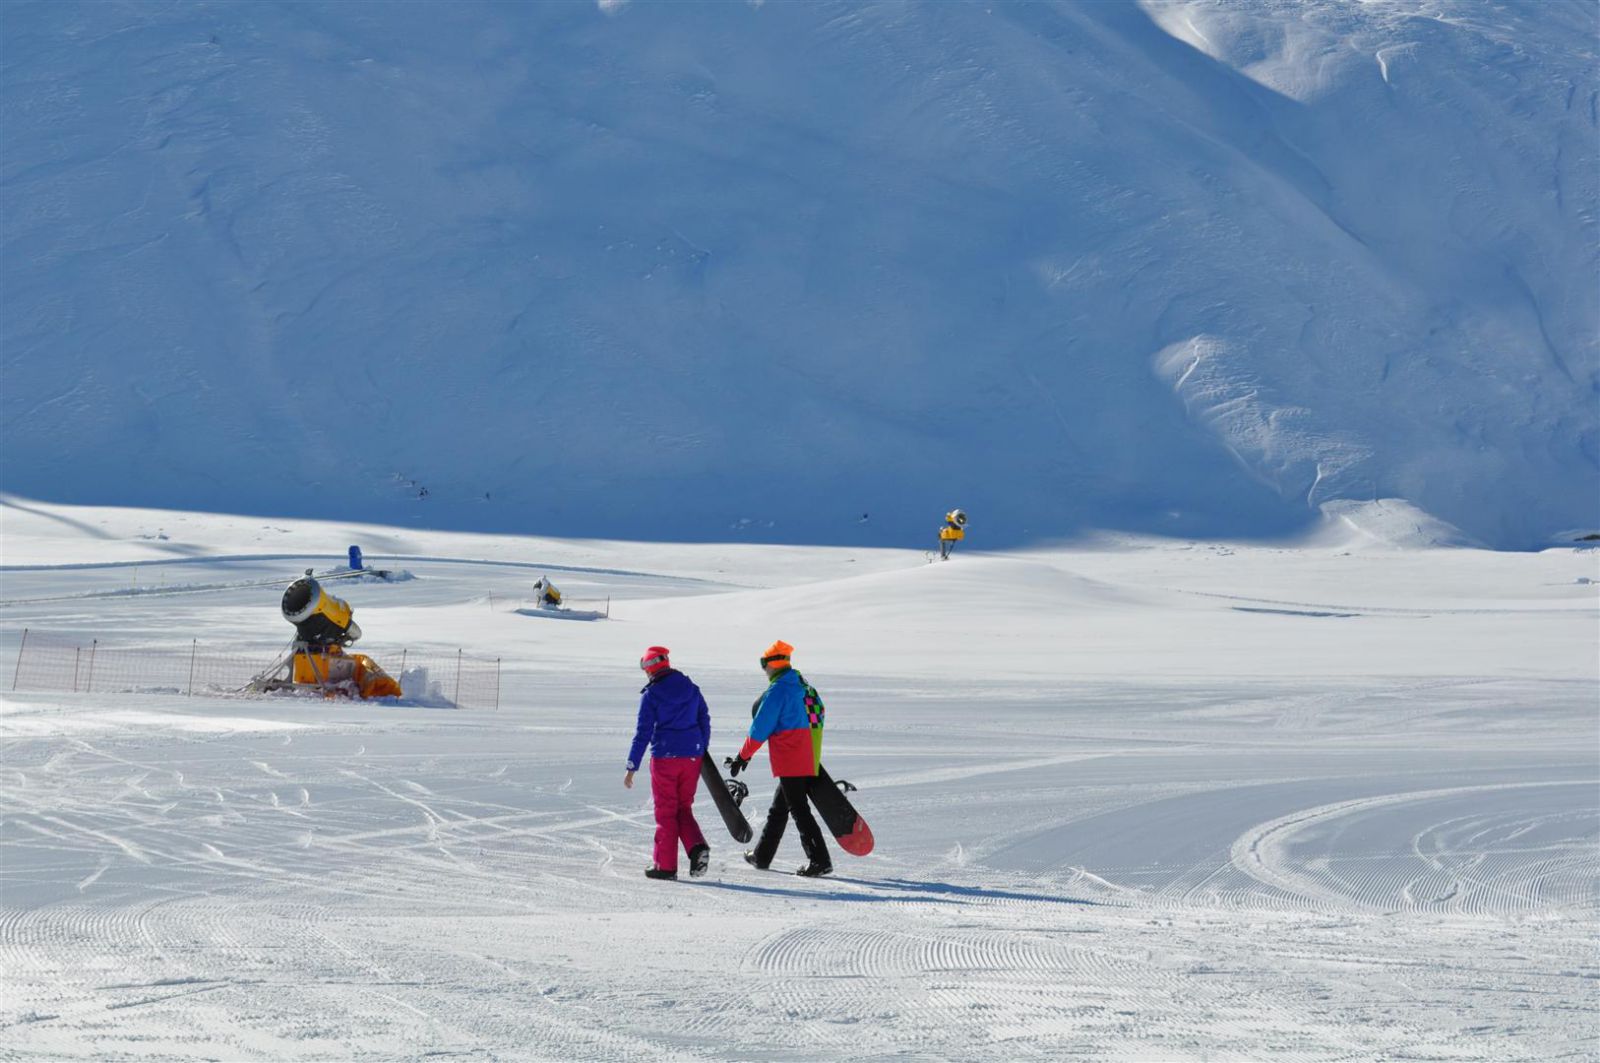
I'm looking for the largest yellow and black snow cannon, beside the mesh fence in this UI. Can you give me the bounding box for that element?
[250,568,402,698]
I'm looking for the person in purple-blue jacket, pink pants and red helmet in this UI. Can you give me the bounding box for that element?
[622,645,710,879]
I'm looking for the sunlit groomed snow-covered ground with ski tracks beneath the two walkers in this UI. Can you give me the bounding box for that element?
[0,503,1600,1060]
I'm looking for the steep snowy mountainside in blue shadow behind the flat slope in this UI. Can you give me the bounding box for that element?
[0,0,1600,546]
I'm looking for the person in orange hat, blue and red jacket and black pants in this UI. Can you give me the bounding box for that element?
[728,639,834,877]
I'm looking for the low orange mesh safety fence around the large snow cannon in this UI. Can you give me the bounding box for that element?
[10,629,501,709]
